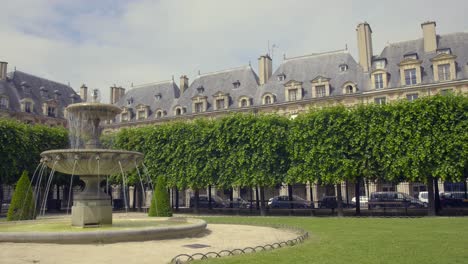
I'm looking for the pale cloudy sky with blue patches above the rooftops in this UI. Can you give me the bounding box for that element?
[0,0,468,102]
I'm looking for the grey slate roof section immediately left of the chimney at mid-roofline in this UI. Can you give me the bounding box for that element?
[176,65,258,114]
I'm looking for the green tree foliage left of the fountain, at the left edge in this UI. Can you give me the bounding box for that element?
[0,119,68,184]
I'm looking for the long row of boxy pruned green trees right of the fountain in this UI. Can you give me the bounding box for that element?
[113,95,468,217]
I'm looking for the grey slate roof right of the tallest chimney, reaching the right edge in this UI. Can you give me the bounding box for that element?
[372,33,468,88]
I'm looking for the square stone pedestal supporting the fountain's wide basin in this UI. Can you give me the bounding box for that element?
[72,175,112,227]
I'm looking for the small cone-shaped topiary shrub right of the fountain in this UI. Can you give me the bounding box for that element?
[148,176,172,216]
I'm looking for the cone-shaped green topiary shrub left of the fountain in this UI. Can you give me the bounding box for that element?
[7,171,35,221]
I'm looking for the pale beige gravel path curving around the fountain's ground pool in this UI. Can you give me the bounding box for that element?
[0,213,297,264]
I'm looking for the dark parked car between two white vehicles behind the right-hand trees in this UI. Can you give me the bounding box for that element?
[368,192,427,209]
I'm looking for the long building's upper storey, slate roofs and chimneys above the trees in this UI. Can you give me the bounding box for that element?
[106,22,468,131]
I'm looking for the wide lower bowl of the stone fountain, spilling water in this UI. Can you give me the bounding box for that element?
[41,149,143,175]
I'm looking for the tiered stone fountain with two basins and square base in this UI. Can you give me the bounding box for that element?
[41,90,143,227]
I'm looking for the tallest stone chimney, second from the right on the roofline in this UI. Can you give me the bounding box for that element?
[356,22,373,72]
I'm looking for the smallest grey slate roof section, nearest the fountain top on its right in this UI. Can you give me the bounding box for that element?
[116,80,180,120]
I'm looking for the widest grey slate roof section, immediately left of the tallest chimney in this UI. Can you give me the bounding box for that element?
[256,50,368,102]
